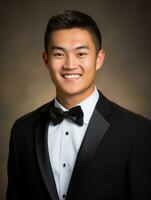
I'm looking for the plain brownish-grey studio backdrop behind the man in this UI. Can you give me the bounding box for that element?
[0,0,151,200]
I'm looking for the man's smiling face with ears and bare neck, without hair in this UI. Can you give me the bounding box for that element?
[43,28,104,100]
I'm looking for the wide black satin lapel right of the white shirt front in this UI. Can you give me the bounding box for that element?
[66,105,110,200]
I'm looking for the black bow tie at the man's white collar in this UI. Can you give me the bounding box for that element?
[50,106,83,126]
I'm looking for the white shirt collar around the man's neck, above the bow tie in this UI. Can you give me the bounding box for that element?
[55,87,99,125]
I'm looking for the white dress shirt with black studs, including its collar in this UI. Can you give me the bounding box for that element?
[48,88,99,200]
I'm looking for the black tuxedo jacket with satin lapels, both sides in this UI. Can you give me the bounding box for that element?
[7,93,151,200]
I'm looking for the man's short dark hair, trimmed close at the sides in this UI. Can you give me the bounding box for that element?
[44,10,102,53]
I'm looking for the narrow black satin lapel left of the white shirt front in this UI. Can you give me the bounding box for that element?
[35,110,59,200]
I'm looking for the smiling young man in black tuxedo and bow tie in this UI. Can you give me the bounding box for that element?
[7,11,151,200]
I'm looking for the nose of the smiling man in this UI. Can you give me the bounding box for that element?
[64,54,77,70]
